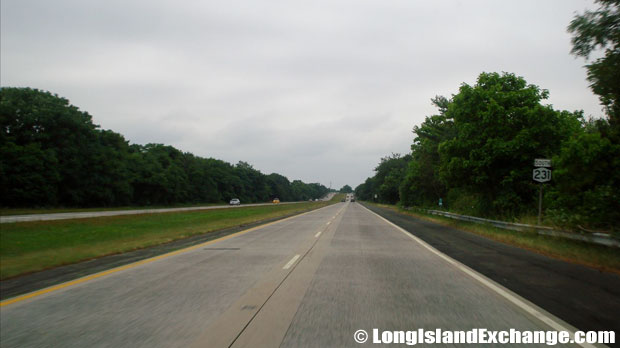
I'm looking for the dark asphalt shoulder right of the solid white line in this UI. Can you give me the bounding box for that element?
[365,205,620,332]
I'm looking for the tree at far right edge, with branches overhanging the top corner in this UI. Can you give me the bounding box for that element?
[568,0,620,231]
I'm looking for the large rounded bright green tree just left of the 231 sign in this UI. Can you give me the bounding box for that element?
[439,73,582,215]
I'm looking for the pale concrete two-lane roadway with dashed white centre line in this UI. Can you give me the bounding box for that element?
[0,203,591,347]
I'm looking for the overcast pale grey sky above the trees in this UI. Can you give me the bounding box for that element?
[0,0,602,188]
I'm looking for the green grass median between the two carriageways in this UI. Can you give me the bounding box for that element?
[0,196,340,280]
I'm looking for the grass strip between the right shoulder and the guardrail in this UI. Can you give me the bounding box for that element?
[375,204,620,274]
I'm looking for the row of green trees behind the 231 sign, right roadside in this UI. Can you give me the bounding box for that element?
[355,0,620,231]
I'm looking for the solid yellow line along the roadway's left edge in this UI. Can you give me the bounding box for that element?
[0,204,331,307]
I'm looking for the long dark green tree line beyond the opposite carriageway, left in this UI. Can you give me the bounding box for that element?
[0,87,329,207]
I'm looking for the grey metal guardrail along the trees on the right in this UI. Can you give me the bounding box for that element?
[427,210,620,248]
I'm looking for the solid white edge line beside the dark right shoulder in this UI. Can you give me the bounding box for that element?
[363,206,596,348]
